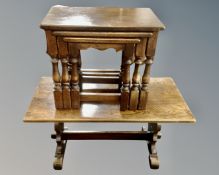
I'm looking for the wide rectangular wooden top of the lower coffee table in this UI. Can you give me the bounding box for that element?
[24,77,196,123]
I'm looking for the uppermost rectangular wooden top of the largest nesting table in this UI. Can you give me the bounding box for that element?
[40,5,165,32]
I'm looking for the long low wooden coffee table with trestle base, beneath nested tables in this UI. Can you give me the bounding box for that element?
[24,77,196,169]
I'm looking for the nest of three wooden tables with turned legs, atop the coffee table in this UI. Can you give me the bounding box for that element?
[41,6,164,110]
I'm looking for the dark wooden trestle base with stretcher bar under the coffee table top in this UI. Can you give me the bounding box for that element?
[51,123,161,170]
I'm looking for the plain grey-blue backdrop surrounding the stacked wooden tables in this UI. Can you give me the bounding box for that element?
[0,0,219,175]
